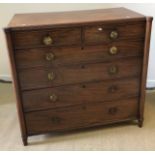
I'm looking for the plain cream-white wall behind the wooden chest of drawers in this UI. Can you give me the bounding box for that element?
[0,3,155,87]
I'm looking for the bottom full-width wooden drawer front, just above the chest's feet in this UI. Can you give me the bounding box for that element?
[25,98,138,134]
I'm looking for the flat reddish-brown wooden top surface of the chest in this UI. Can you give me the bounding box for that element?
[7,8,146,30]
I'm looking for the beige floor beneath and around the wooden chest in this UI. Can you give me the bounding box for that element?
[0,84,155,150]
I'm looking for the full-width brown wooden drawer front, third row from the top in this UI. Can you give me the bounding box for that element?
[19,58,142,90]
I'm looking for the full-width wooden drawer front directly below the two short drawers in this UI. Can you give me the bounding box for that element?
[15,41,143,68]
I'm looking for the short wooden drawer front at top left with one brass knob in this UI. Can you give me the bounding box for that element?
[13,28,81,49]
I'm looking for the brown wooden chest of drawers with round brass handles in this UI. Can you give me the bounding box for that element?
[5,8,152,145]
